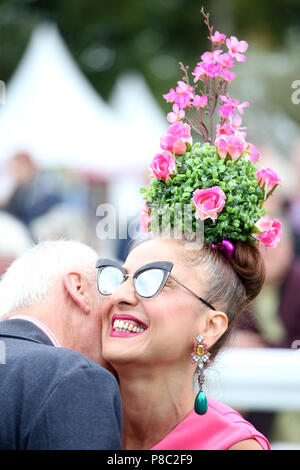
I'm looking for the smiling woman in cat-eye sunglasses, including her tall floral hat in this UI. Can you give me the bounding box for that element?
[97,10,281,450]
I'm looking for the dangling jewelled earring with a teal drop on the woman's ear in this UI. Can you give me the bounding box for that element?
[191,335,210,415]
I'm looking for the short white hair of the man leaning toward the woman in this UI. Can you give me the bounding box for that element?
[0,240,98,318]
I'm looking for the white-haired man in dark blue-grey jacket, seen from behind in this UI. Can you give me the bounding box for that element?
[0,241,121,450]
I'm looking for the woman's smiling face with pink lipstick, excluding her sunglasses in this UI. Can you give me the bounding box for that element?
[102,239,209,367]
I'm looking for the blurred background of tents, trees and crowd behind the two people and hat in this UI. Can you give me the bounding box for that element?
[0,0,300,448]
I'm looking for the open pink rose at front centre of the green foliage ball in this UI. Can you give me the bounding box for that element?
[193,186,226,220]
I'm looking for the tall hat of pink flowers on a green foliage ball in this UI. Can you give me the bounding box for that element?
[141,9,281,256]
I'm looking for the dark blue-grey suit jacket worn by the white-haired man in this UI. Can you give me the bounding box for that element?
[0,319,121,450]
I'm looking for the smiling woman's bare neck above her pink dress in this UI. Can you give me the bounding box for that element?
[119,368,195,450]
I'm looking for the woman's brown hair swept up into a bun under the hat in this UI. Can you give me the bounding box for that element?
[184,241,266,359]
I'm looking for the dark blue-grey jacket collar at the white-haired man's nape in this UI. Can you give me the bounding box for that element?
[0,318,54,346]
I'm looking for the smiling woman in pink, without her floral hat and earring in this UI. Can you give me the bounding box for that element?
[98,238,269,450]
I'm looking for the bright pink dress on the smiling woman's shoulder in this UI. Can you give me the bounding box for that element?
[151,398,270,450]
